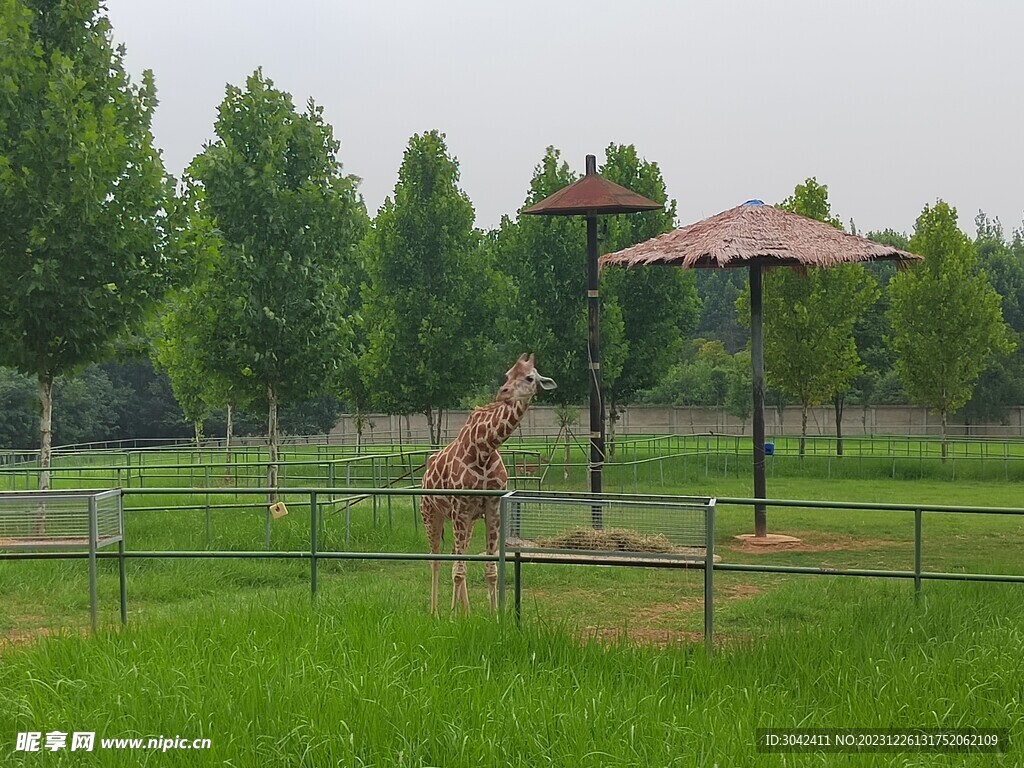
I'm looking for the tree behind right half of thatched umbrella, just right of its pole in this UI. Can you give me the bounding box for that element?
[744,177,879,456]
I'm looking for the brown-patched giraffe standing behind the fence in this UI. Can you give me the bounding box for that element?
[420,354,557,615]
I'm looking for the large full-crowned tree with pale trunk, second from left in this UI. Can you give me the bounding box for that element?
[190,70,366,499]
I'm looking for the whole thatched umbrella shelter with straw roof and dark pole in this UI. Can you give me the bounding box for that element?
[601,200,922,537]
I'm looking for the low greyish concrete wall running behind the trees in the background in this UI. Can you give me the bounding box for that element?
[331,404,1024,442]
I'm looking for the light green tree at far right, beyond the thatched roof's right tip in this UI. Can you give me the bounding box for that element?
[889,201,1014,459]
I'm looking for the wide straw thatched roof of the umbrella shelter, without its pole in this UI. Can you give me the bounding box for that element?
[601,201,922,269]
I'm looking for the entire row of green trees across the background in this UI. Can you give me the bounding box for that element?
[0,0,1024,482]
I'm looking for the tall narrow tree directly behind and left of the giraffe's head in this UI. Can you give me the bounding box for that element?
[364,131,497,444]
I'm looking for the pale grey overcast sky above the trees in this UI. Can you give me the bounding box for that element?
[108,0,1024,233]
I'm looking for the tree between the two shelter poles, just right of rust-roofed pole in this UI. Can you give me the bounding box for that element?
[601,143,700,456]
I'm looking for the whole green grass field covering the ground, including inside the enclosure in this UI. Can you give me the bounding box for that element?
[0,442,1024,766]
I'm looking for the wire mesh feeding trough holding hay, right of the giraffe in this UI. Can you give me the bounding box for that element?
[502,492,714,558]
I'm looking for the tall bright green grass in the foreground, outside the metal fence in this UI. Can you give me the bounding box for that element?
[0,578,1024,768]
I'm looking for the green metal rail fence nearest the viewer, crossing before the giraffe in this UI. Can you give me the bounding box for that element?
[0,487,1024,652]
